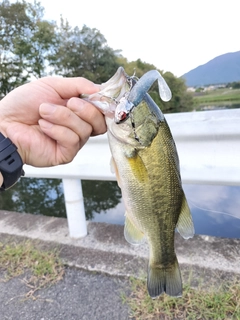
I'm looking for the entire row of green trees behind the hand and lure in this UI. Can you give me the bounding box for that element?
[0,0,192,113]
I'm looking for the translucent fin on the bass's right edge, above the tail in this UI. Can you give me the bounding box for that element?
[177,195,195,239]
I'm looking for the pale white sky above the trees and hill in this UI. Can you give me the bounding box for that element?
[28,0,240,77]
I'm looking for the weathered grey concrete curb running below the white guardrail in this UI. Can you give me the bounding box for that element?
[0,211,240,284]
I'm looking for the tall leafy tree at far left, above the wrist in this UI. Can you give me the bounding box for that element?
[0,0,56,96]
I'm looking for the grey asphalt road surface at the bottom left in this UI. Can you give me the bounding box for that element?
[0,268,129,320]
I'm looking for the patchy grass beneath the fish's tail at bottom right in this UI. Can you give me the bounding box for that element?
[122,278,240,320]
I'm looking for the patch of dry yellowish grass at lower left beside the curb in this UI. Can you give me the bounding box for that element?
[0,241,64,298]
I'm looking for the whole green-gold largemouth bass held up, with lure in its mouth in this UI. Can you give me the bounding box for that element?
[82,67,194,298]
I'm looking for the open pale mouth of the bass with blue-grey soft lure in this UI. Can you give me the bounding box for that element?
[80,67,172,124]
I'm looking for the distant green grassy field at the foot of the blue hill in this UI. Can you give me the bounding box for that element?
[193,88,240,104]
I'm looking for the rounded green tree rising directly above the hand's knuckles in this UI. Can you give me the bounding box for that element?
[51,19,119,83]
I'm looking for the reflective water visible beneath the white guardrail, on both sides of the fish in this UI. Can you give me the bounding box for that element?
[0,178,240,238]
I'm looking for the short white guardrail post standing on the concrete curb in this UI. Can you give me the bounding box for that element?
[63,179,87,238]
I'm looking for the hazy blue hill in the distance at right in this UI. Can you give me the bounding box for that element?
[181,51,240,87]
